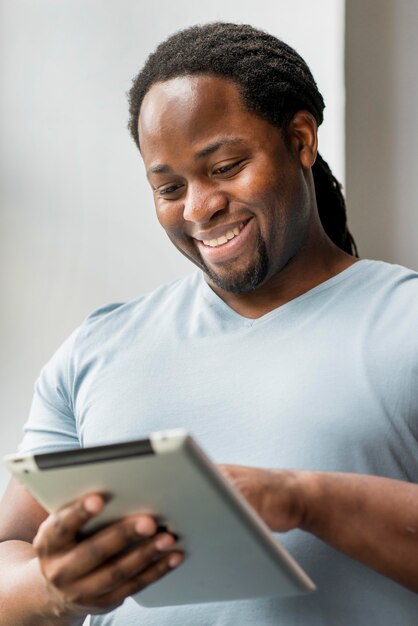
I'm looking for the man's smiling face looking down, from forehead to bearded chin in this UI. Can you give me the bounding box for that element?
[138,75,310,293]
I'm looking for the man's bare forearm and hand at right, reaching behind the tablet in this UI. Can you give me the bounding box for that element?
[220,465,418,593]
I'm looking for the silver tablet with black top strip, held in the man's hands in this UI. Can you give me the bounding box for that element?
[5,430,315,607]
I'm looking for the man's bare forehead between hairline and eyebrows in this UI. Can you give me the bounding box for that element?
[138,75,284,174]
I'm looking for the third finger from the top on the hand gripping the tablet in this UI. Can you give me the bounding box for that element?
[59,533,180,603]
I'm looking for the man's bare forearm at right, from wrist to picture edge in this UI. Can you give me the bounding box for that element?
[296,472,418,592]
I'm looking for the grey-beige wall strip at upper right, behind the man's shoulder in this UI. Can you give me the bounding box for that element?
[346,0,418,270]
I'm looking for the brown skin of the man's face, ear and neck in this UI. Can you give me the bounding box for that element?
[138,76,356,318]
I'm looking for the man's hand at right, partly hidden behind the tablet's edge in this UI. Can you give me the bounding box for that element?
[218,465,305,532]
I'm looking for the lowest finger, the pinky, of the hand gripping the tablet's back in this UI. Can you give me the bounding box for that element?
[71,552,184,609]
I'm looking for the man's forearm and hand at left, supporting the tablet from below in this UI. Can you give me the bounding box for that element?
[0,480,181,626]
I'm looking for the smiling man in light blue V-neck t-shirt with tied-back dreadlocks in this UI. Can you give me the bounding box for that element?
[0,24,418,626]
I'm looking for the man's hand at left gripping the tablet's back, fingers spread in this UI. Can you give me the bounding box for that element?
[33,494,183,618]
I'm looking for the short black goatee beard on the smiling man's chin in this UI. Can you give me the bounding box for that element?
[199,233,269,293]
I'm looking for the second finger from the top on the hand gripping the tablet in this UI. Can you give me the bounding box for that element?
[45,515,160,587]
